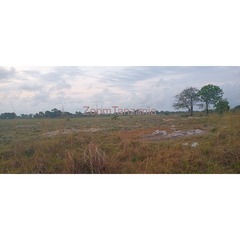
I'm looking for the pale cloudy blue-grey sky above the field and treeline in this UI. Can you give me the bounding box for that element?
[0,66,240,115]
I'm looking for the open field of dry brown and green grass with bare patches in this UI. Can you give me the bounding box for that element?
[0,112,240,173]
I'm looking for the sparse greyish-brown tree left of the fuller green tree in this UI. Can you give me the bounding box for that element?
[173,87,199,116]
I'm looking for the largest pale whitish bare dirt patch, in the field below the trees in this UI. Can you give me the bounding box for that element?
[142,129,205,141]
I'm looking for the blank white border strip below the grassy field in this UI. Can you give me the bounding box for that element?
[0,175,240,240]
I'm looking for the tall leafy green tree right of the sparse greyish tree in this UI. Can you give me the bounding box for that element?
[199,84,223,114]
